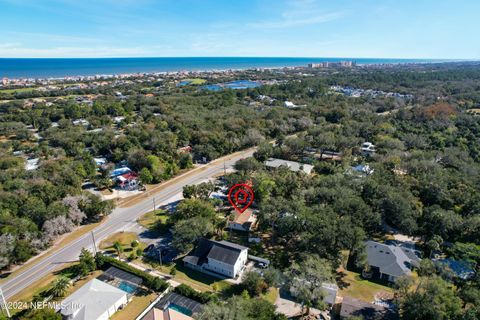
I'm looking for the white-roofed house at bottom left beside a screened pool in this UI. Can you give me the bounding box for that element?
[58,279,128,320]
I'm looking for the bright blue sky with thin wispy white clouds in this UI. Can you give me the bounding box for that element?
[0,0,480,59]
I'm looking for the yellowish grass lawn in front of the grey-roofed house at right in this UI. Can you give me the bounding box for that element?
[337,270,393,302]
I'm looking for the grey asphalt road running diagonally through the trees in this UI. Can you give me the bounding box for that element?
[1,149,254,301]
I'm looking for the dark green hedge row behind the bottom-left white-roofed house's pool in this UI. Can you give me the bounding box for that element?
[95,253,170,292]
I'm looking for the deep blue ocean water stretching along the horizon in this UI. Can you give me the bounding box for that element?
[0,57,440,79]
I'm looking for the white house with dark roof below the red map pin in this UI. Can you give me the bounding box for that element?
[183,238,248,278]
